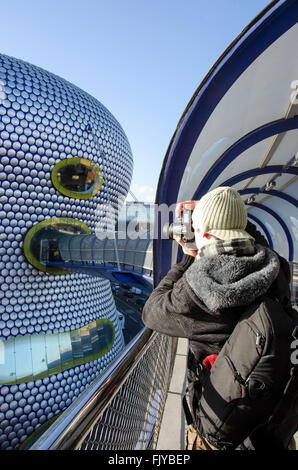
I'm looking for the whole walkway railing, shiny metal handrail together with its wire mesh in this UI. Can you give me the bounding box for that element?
[30,328,177,450]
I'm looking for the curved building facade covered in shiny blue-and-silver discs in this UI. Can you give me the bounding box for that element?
[0,54,133,449]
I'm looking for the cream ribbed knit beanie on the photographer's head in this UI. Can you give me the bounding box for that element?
[192,186,254,240]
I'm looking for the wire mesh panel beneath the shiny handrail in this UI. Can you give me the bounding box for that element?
[77,334,177,450]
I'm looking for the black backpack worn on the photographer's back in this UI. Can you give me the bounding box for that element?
[183,297,298,450]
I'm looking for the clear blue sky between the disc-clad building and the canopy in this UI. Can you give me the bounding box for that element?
[0,0,269,201]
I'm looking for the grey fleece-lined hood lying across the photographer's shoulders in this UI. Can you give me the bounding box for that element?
[185,245,280,312]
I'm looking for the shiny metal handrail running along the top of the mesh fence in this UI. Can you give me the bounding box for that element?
[30,328,157,450]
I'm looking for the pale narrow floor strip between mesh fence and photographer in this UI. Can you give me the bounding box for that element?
[157,338,298,450]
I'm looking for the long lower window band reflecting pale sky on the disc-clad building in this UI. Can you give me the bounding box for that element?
[0,319,115,384]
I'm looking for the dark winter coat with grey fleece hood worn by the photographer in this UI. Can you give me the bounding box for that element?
[142,223,290,361]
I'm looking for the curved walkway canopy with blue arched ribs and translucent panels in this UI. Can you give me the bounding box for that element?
[154,0,298,284]
